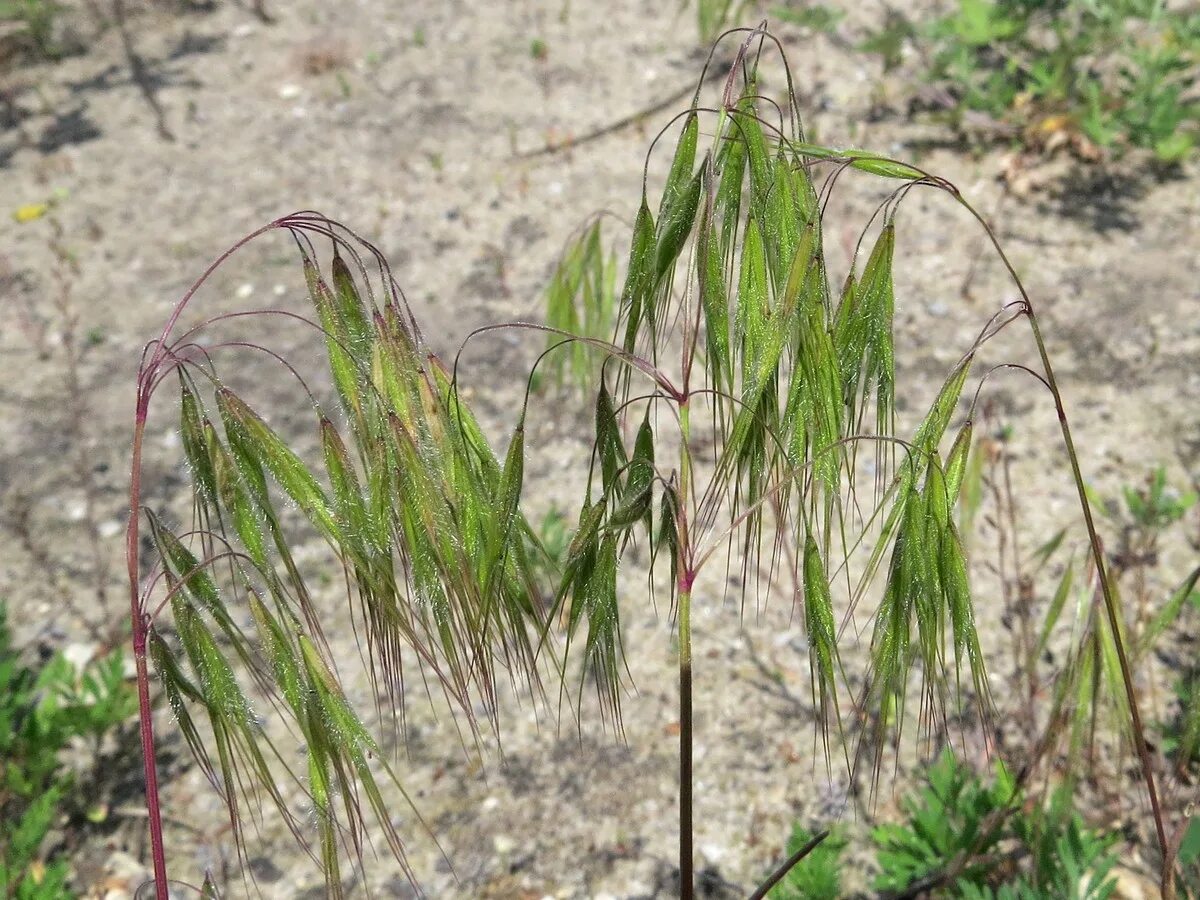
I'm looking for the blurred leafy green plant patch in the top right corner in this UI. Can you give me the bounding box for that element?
[863,0,1200,163]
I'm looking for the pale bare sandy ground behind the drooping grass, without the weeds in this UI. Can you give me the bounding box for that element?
[0,0,1200,898]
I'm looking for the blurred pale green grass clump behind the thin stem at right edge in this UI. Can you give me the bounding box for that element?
[959,422,1200,792]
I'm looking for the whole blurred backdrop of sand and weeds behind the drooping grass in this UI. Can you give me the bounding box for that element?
[0,0,1200,900]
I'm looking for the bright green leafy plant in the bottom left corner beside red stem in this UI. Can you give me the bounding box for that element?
[0,605,137,900]
